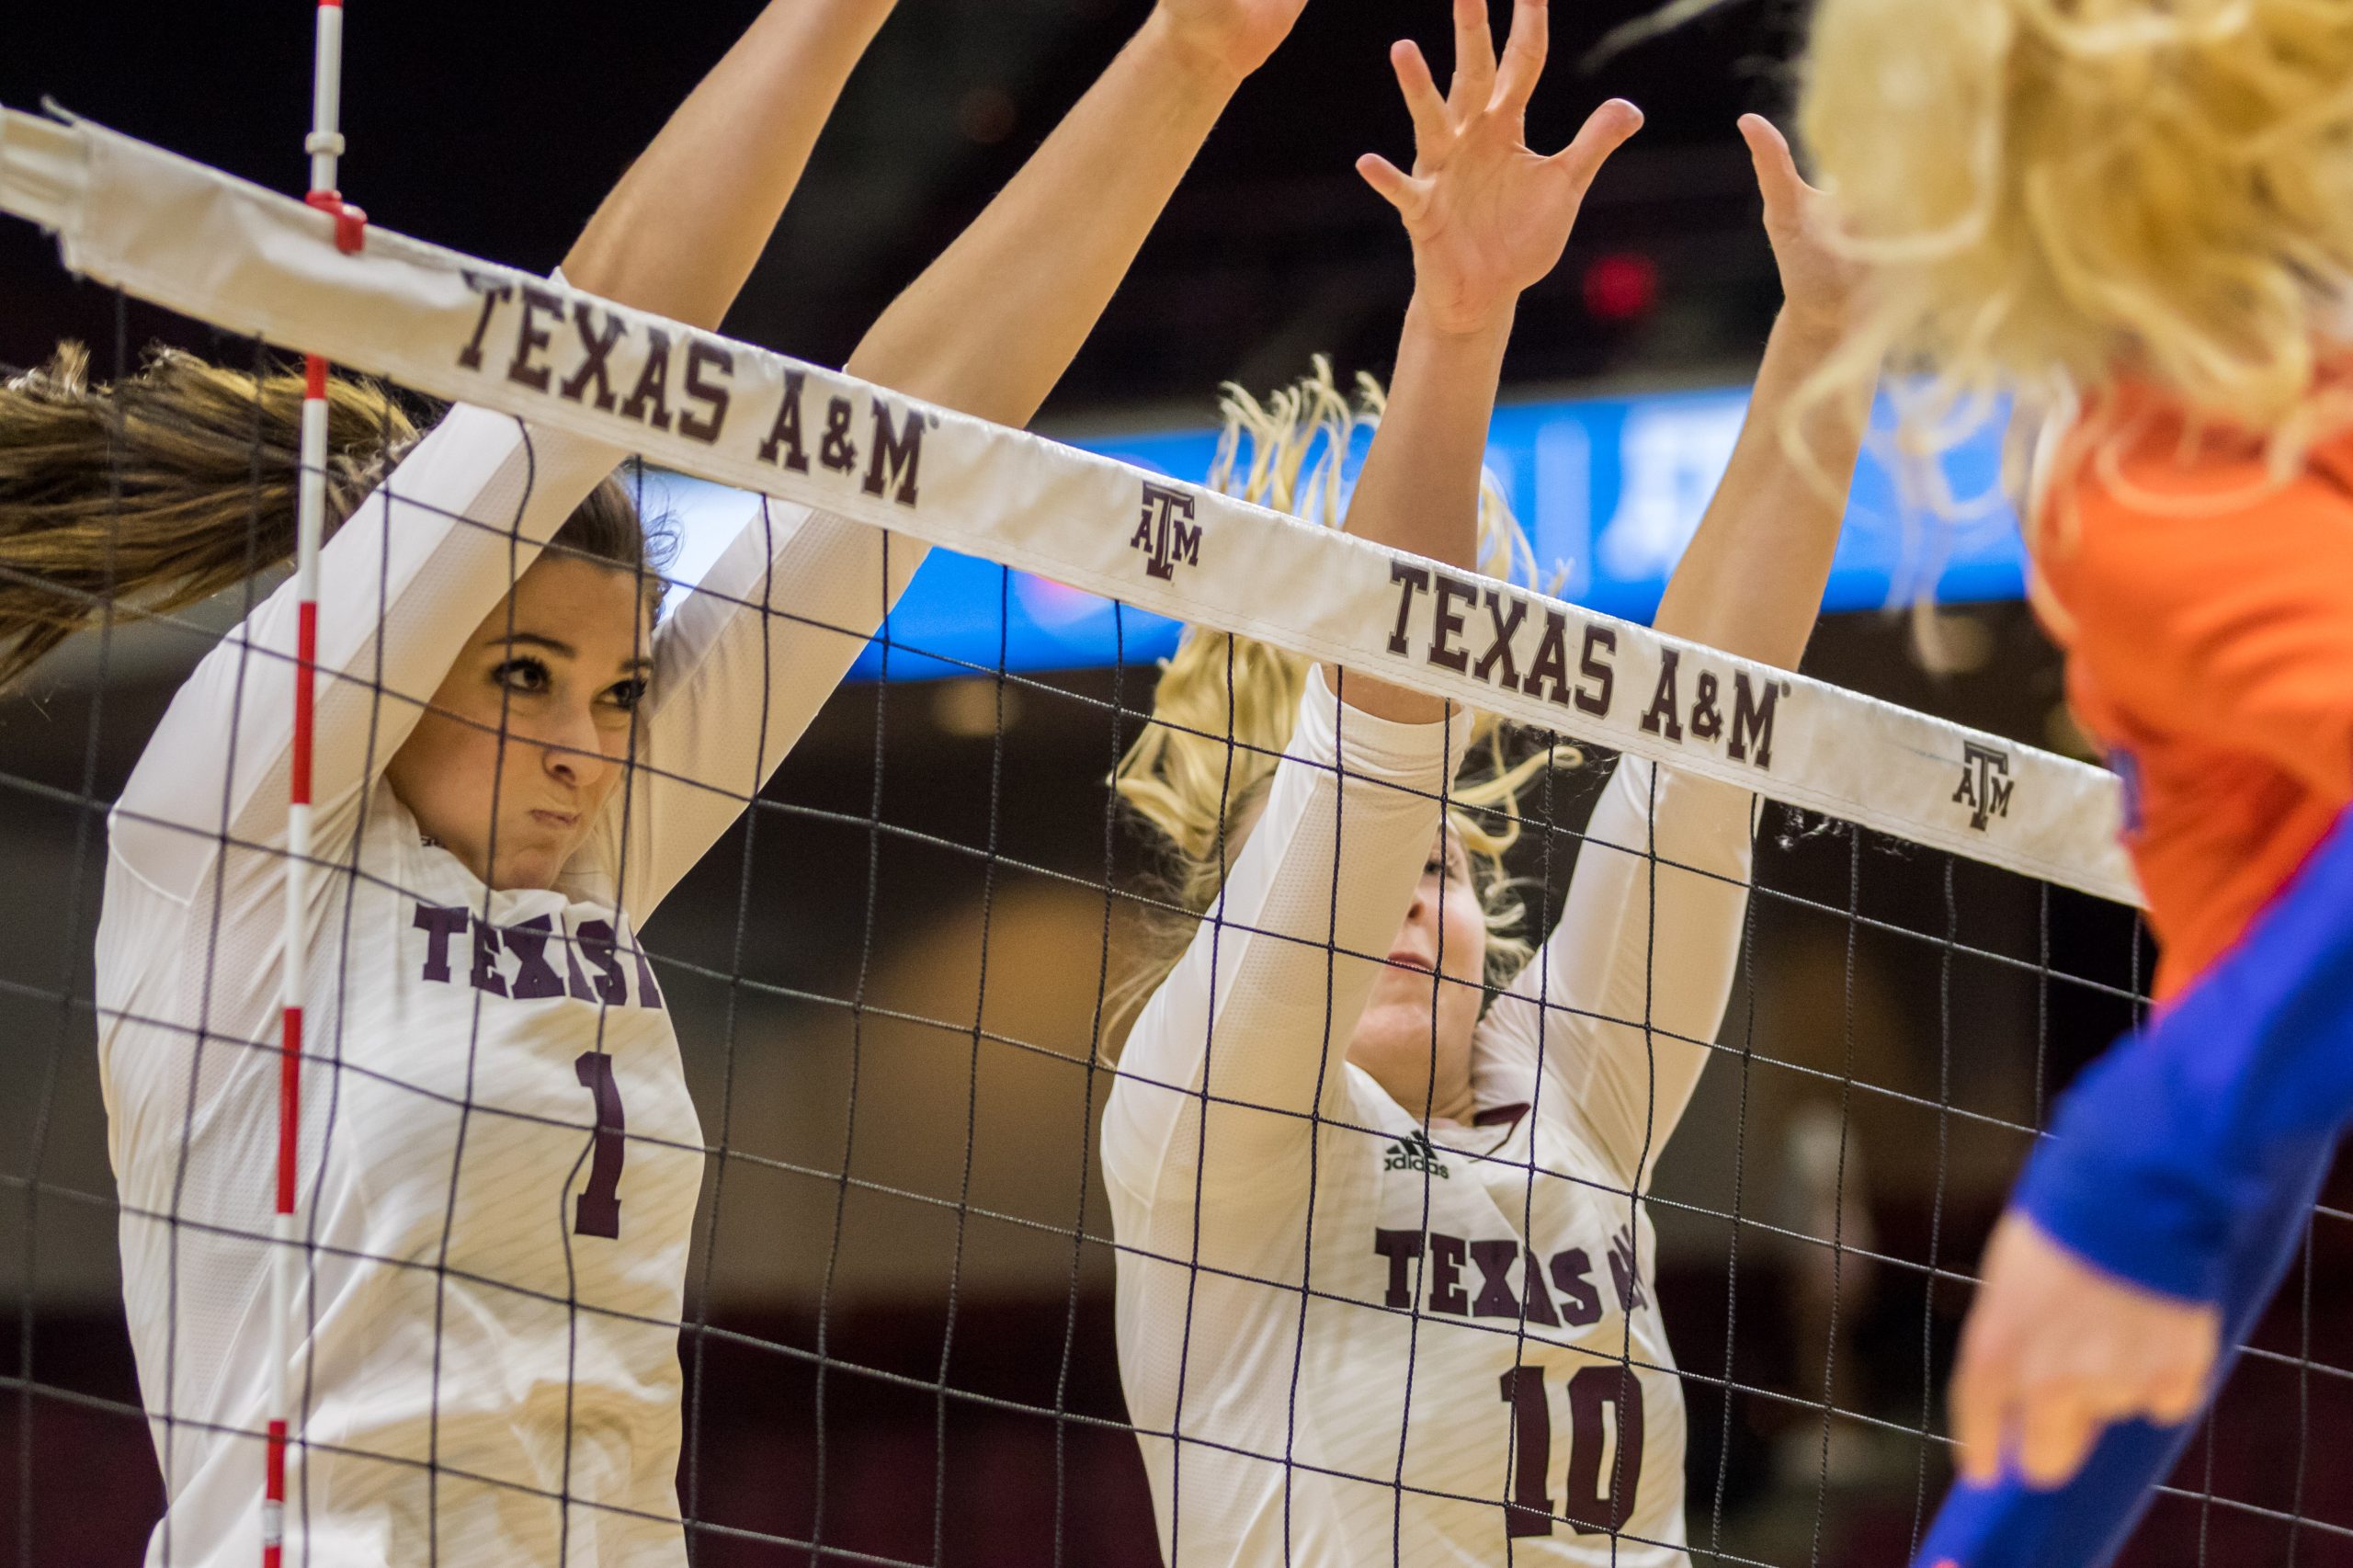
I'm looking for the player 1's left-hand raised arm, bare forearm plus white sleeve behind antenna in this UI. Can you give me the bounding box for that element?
[113,0,892,900]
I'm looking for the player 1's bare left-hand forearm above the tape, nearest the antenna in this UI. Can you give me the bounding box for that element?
[564,0,894,330]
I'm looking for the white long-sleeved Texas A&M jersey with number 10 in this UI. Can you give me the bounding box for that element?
[1104,676,1753,1568]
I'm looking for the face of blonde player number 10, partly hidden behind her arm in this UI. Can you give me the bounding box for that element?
[1348,829,1487,1123]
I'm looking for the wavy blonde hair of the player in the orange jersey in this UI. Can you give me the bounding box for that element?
[1798,0,2353,492]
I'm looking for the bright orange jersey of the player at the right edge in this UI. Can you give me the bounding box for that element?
[2033,391,2353,996]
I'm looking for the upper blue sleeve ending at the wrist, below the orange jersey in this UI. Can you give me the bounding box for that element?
[2014,795,2353,1302]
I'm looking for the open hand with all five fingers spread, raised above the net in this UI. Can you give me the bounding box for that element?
[1356,0,1643,332]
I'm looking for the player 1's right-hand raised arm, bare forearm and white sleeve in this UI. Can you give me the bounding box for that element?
[597,0,1303,915]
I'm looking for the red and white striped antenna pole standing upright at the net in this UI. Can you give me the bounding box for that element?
[261,0,367,1568]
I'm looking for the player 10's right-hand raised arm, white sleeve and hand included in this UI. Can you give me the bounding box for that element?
[1483,116,1870,1187]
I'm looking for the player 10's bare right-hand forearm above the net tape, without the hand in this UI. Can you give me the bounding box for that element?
[1656,311,1870,668]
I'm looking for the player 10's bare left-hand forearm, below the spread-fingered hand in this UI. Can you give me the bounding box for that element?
[1339,294,1518,722]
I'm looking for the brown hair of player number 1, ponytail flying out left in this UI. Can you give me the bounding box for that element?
[0,344,661,687]
